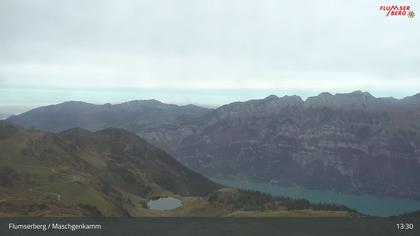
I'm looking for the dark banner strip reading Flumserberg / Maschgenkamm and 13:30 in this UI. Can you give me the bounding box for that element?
[0,217,420,236]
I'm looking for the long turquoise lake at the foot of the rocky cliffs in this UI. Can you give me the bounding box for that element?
[210,178,420,216]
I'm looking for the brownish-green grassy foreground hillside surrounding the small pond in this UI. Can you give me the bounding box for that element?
[0,121,356,217]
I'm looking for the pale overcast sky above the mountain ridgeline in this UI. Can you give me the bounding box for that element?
[0,0,420,113]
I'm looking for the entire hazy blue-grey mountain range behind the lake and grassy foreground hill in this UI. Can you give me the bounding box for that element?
[8,91,420,199]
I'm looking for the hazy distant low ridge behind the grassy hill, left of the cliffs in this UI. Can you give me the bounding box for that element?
[7,100,210,132]
